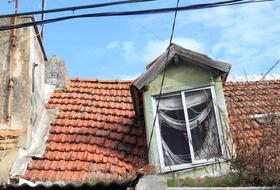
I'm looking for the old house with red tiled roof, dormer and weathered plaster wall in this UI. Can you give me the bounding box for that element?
[0,17,280,188]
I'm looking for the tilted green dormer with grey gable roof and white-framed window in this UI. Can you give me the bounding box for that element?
[131,44,232,173]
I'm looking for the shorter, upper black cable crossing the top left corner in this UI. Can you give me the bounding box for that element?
[0,0,156,18]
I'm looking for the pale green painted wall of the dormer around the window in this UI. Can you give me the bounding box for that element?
[144,63,232,177]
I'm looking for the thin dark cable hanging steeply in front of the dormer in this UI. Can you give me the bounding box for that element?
[148,0,180,152]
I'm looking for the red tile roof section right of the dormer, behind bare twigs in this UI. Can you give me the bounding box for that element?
[224,80,280,146]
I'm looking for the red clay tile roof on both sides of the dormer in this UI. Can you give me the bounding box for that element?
[23,76,280,182]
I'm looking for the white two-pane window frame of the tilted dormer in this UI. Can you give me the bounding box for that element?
[152,85,226,172]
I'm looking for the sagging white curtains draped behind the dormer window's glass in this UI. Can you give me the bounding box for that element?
[159,90,217,165]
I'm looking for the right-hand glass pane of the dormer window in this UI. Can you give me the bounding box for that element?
[185,89,221,160]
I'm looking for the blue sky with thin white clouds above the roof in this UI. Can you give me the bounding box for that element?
[0,0,280,79]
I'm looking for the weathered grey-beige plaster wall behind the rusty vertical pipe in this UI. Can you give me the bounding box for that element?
[0,17,44,129]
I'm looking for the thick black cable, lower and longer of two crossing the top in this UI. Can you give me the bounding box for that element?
[0,0,274,31]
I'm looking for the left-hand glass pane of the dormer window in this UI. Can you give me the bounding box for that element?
[159,95,191,166]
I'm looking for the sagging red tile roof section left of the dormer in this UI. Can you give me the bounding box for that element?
[23,79,146,182]
